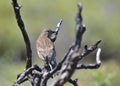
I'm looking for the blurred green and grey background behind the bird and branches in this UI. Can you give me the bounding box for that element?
[0,0,120,86]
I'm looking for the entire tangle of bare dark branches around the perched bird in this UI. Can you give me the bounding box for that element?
[12,0,101,86]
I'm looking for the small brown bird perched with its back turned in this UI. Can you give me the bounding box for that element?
[36,29,57,71]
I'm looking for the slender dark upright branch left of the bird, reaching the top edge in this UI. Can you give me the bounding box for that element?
[12,0,32,69]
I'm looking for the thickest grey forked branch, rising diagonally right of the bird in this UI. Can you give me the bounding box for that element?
[52,3,101,86]
